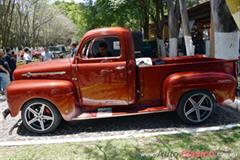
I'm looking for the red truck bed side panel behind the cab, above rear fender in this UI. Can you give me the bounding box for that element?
[137,56,237,105]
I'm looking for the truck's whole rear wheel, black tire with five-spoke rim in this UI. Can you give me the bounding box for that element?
[177,90,216,124]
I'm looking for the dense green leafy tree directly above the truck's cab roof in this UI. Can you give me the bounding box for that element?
[55,0,147,39]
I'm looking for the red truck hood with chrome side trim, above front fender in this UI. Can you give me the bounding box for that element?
[13,58,73,80]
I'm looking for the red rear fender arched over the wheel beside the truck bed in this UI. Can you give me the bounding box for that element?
[163,72,236,110]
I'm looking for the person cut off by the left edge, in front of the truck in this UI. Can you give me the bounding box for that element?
[0,51,10,94]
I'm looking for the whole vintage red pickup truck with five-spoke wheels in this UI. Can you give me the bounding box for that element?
[4,27,237,134]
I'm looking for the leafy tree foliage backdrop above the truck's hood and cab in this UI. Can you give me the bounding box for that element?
[0,0,208,48]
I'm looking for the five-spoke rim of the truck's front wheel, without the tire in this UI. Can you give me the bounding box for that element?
[24,103,54,132]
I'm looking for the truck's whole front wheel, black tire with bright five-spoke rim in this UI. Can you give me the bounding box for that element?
[21,99,62,134]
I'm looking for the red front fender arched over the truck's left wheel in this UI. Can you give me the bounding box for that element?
[7,80,79,120]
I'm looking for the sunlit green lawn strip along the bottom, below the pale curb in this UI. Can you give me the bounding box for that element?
[0,128,240,160]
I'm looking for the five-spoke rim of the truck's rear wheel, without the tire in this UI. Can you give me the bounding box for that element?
[184,93,214,123]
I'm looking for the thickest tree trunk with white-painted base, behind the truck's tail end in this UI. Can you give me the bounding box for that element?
[211,0,239,59]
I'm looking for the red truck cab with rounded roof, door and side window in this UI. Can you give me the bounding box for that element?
[74,28,136,110]
